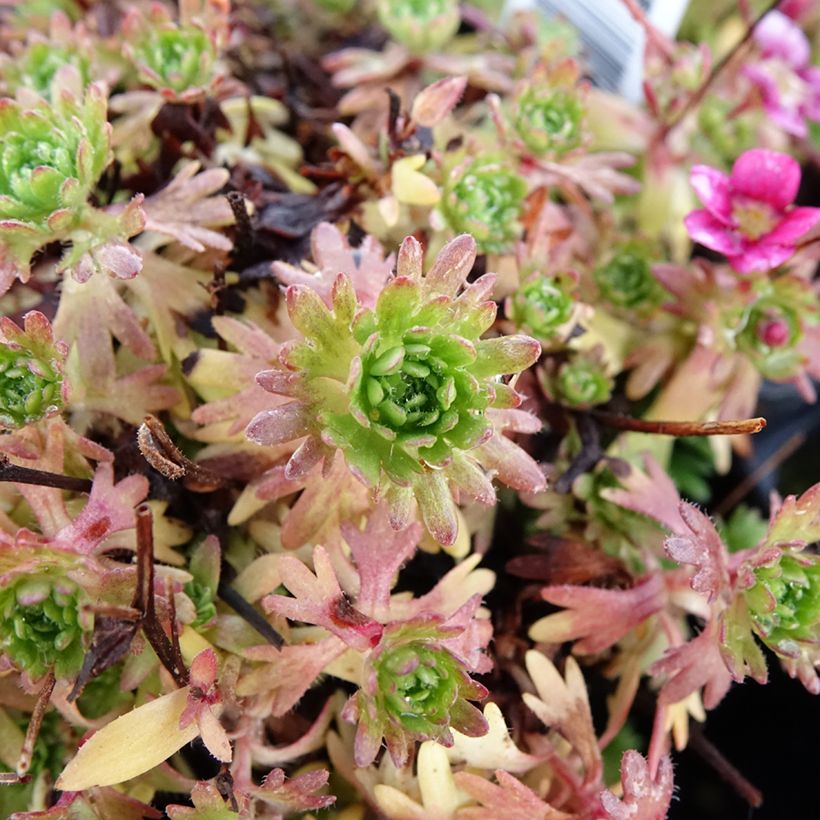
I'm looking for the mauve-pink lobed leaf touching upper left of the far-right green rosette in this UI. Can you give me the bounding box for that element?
[664,502,729,603]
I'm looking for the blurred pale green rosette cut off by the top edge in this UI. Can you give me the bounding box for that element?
[376,0,461,53]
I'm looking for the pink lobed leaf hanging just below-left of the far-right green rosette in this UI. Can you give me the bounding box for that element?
[650,622,732,709]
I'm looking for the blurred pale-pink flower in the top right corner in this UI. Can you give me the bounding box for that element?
[743,11,820,138]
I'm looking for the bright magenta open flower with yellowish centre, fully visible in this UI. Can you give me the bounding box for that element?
[684,148,820,273]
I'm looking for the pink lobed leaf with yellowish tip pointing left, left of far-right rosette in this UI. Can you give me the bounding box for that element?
[529,574,665,655]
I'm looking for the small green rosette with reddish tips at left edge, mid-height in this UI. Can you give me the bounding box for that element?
[0,311,68,429]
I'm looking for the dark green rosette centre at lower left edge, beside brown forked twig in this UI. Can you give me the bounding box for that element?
[0,574,91,678]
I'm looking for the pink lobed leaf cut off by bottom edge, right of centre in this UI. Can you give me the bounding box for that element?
[600,749,674,820]
